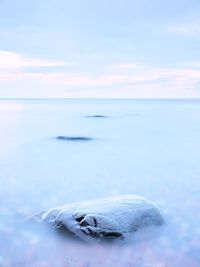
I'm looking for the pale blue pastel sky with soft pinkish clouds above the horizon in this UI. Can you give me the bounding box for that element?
[0,0,200,98]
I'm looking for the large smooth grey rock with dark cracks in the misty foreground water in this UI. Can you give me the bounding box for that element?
[34,195,163,242]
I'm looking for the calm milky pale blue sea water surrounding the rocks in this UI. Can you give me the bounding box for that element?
[0,100,200,267]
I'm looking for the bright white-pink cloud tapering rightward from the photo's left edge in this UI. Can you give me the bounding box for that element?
[0,51,65,71]
